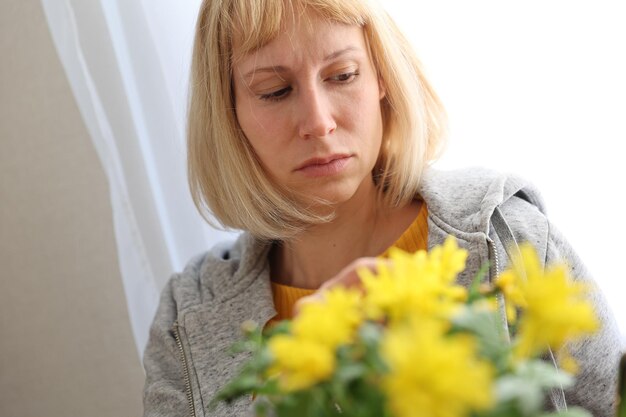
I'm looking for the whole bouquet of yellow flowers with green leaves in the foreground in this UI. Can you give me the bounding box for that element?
[214,238,599,417]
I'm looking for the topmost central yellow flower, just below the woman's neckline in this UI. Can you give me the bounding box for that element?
[358,238,467,322]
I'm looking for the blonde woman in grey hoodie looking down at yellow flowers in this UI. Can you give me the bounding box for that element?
[144,0,619,417]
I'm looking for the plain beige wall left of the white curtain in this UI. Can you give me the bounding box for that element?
[0,0,143,417]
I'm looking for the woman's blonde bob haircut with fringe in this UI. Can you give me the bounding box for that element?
[187,0,447,240]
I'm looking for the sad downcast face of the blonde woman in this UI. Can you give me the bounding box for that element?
[233,15,384,204]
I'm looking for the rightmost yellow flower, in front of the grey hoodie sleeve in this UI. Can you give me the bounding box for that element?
[497,244,599,358]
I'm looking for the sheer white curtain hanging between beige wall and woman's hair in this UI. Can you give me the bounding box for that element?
[42,0,234,355]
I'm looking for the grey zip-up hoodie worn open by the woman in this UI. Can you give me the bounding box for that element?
[144,169,621,417]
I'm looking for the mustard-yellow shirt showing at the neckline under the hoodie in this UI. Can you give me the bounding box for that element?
[268,203,428,325]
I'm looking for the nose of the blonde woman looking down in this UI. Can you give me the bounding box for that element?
[296,87,337,139]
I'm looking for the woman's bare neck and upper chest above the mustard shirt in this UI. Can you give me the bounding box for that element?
[270,182,420,289]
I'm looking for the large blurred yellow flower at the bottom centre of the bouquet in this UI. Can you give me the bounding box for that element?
[381,320,494,417]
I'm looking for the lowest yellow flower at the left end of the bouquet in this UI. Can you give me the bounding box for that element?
[268,335,335,392]
